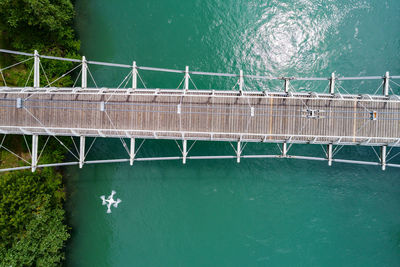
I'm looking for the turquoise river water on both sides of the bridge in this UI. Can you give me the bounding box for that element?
[65,0,400,266]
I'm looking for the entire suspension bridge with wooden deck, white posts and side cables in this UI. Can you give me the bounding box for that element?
[0,49,400,171]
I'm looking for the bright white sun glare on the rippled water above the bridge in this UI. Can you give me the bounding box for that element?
[237,1,369,75]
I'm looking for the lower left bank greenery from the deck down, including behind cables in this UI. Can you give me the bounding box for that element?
[0,135,72,266]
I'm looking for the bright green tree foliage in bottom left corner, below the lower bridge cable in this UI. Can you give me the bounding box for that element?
[0,168,69,266]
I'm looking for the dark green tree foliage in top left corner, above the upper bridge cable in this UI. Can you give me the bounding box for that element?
[0,0,79,56]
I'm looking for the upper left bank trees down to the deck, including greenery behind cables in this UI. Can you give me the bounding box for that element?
[0,0,80,86]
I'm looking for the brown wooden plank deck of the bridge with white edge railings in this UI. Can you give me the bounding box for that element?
[0,88,400,146]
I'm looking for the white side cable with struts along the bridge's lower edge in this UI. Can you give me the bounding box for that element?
[0,138,400,173]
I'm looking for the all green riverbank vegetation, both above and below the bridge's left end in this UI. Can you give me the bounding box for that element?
[0,0,80,266]
